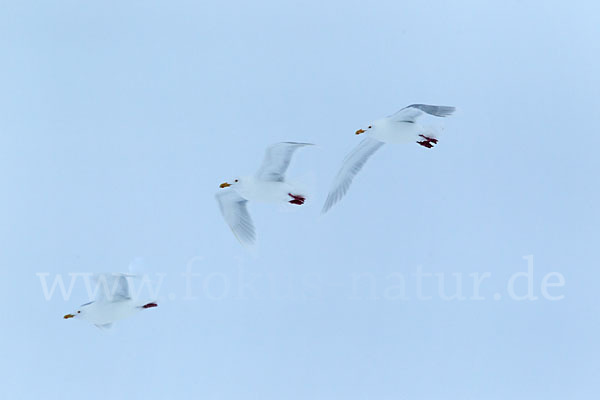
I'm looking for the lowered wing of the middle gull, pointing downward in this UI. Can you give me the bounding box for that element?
[215,189,256,245]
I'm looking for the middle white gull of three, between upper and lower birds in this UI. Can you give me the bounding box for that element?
[216,142,313,246]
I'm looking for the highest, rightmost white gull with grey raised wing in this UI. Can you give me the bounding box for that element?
[322,104,455,213]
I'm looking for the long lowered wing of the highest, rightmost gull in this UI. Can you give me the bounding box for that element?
[322,137,383,213]
